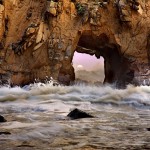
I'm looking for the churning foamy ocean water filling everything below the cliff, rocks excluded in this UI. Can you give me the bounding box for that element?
[0,81,150,150]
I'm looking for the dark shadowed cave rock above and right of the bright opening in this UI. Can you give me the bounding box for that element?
[76,31,134,87]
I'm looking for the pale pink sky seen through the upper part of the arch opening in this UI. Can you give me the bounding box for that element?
[73,52,104,71]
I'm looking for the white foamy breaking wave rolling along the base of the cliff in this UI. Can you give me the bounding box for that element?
[0,83,150,109]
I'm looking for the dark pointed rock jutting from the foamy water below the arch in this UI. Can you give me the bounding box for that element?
[67,108,94,119]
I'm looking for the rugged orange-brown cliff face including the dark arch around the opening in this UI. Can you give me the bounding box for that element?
[0,0,150,86]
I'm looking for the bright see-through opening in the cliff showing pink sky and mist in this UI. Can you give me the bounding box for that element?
[72,52,104,85]
